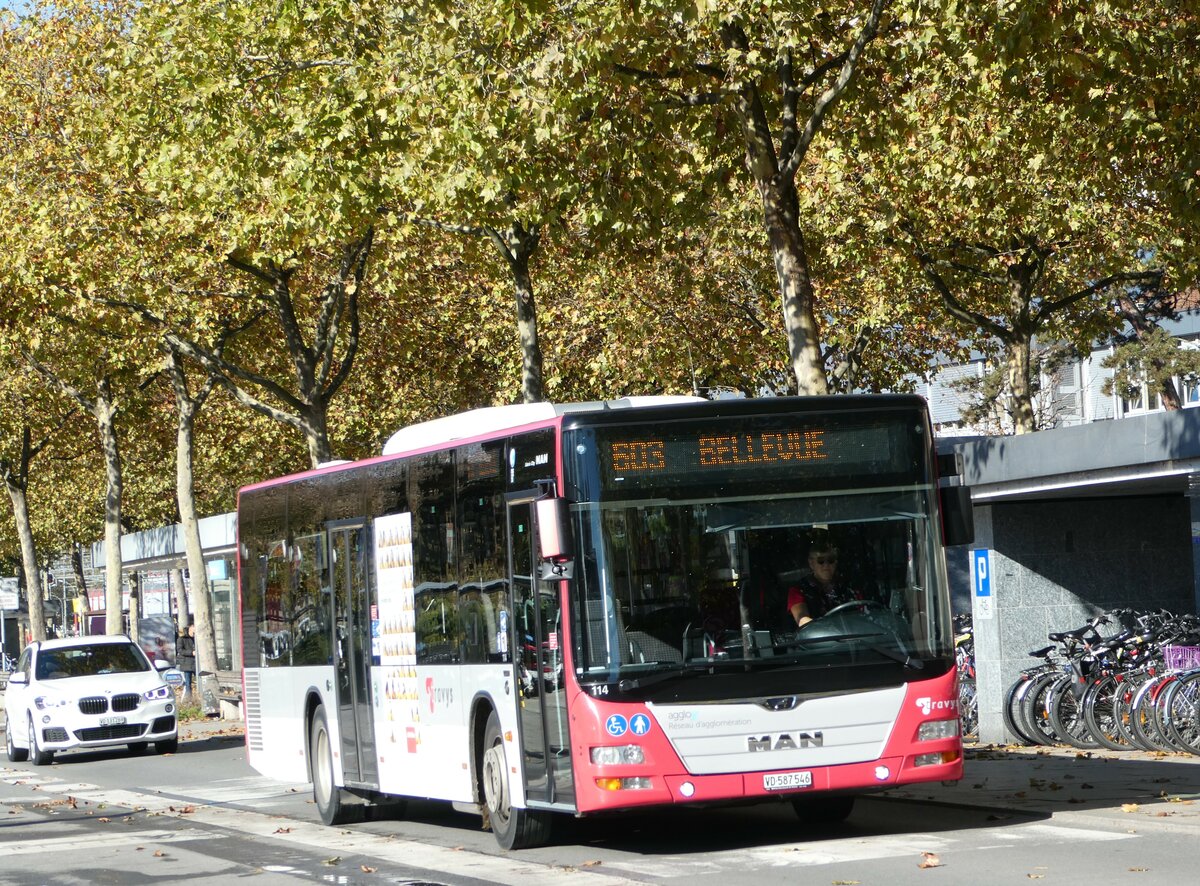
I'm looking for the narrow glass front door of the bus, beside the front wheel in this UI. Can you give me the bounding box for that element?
[509,499,575,809]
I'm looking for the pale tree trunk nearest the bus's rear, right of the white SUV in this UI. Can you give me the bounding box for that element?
[175,405,222,713]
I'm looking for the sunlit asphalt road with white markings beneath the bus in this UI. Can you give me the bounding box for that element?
[0,724,1200,886]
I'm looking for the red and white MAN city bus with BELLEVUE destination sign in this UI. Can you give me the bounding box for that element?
[238,396,970,848]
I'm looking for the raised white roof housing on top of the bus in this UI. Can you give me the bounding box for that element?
[383,394,704,455]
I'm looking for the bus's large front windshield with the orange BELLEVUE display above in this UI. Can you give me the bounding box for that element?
[564,412,953,699]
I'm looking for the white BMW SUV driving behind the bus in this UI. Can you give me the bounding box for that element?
[4,636,179,766]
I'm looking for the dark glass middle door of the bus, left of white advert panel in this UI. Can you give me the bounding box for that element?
[329,523,379,785]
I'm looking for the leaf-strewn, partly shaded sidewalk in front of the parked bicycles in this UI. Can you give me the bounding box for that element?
[888,744,1200,830]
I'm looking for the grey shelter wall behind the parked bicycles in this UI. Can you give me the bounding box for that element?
[973,496,1195,742]
